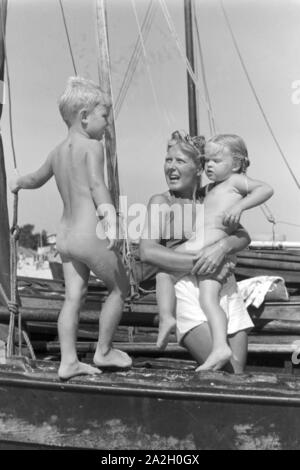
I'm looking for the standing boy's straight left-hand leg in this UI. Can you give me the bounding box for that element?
[58,256,100,380]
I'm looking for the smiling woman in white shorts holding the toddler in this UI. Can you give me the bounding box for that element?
[140,132,253,373]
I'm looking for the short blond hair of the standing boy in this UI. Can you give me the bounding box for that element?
[58,77,111,127]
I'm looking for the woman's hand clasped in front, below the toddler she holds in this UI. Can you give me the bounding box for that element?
[191,242,227,276]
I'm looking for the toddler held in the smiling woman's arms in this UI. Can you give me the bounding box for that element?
[159,134,273,370]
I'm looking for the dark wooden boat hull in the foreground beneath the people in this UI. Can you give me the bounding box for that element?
[0,361,300,450]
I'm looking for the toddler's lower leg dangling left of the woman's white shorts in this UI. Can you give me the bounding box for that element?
[156,273,176,349]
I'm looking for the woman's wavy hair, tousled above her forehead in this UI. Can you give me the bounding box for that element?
[167,131,205,169]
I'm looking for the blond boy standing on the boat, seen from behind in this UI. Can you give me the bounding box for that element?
[10,77,132,379]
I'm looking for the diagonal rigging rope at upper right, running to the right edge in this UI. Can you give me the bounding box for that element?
[220,0,300,189]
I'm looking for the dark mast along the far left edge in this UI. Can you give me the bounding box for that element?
[0,0,10,305]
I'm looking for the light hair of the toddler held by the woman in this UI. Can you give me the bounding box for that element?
[207,134,250,173]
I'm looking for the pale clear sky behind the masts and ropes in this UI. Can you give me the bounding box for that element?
[1,0,300,241]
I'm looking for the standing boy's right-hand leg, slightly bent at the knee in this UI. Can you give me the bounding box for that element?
[91,248,132,368]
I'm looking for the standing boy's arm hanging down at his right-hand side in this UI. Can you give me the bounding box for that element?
[86,140,118,250]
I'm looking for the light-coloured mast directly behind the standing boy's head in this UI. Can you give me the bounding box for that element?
[96,0,120,210]
